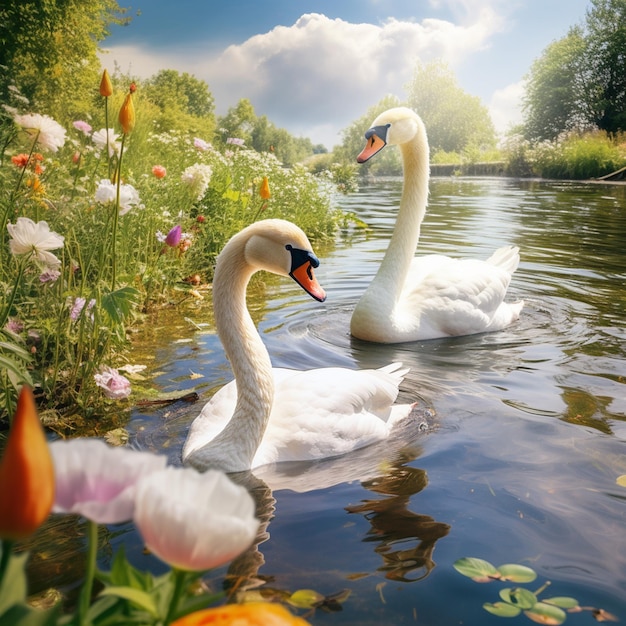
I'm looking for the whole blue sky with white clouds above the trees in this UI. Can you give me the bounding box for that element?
[101,0,590,149]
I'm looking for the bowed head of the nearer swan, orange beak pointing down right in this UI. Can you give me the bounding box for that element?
[240,219,326,302]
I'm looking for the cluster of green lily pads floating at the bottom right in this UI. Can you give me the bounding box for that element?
[453,557,618,626]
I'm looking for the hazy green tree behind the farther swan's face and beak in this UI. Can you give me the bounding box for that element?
[333,95,402,174]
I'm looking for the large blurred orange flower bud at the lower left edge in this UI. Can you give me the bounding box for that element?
[0,386,54,540]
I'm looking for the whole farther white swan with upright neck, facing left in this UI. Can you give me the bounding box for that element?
[350,107,524,343]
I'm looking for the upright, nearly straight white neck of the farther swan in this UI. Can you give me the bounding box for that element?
[372,132,430,303]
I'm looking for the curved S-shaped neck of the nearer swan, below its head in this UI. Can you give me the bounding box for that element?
[205,240,274,471]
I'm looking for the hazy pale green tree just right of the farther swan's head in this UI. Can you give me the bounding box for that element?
[407,61,496,152]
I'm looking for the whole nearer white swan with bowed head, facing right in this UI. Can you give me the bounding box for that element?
[183,219,412,472]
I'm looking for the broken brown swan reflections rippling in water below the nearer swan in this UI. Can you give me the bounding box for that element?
[219,448,450,600]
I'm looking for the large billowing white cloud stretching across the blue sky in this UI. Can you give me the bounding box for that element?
[103,11,502,147]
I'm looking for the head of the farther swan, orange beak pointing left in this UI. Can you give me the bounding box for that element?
[356,107,426,163]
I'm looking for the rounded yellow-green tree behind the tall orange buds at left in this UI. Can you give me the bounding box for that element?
[144,70,215,137]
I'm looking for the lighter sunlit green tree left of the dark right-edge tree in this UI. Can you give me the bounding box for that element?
[522,27,587,141]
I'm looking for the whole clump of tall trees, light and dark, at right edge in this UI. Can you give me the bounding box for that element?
[523,0,626,140]
